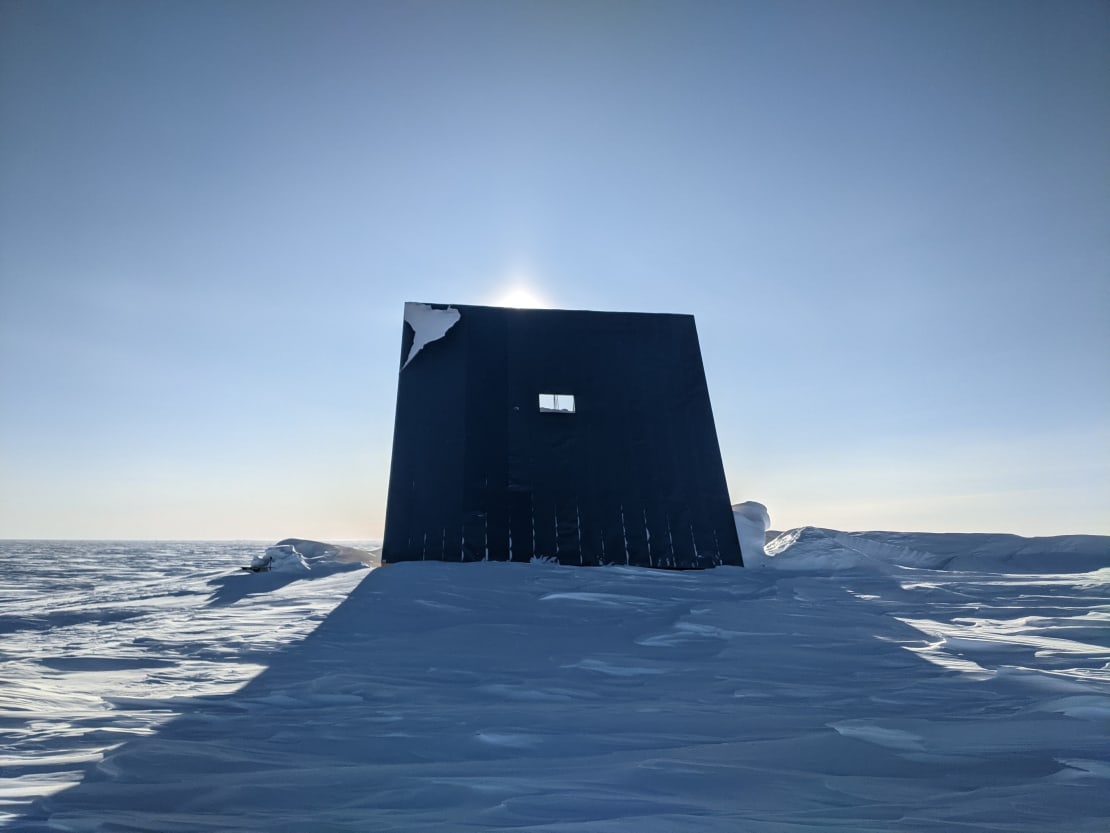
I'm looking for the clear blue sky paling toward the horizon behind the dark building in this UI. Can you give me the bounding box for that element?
[0,0,1110,539]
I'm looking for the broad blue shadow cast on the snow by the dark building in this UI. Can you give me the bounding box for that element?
[11,562,1110,833]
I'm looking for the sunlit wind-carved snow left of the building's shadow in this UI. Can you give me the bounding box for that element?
[0,540,371,829]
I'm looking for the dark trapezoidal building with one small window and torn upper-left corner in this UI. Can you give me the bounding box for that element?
[382,303,743,569]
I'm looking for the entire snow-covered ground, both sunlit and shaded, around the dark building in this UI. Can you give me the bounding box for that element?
[0,528,1110,833]
